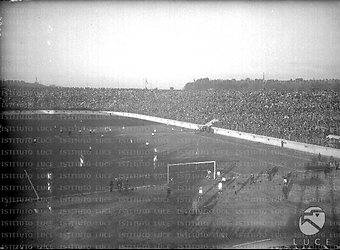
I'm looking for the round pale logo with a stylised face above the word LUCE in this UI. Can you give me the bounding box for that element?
[299,207,326,235]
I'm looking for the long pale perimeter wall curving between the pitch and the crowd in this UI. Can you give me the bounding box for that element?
[4,110,340,158]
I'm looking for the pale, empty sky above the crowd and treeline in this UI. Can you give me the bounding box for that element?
[0,1,340,89]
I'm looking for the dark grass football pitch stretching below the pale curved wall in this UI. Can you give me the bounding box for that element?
[1,113,340,249]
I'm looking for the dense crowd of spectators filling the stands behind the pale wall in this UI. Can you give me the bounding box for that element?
[1,87,340,146]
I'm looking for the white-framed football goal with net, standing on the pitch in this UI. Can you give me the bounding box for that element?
[167,161,216,184]
